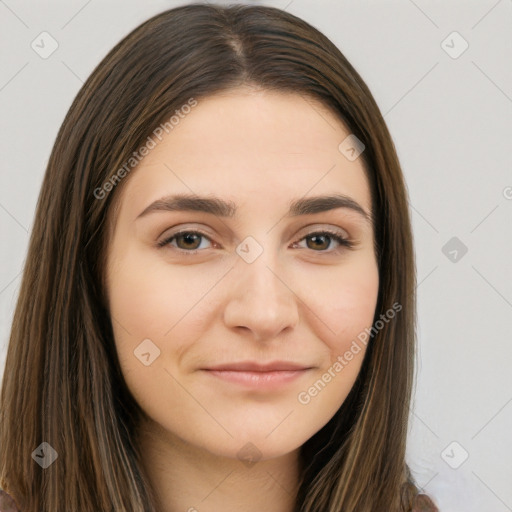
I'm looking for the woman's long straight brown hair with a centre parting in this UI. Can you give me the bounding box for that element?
[0,4,435,512]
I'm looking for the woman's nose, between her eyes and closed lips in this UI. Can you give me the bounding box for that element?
[224,251,299,341]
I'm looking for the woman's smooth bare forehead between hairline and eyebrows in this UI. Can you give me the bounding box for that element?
[111,88,371,225]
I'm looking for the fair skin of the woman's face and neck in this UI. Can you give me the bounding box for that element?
[107,87,379,512]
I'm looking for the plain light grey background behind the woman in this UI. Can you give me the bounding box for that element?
[0,0,512,512]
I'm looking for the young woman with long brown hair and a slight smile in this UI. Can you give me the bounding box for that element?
[0,5,437,512]
